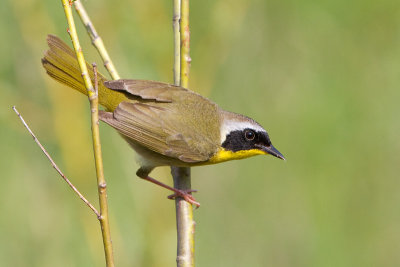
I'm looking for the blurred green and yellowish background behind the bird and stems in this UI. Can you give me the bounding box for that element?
[0,0,400,267]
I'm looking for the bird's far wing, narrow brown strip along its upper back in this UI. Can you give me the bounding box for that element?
[104,79,188,103]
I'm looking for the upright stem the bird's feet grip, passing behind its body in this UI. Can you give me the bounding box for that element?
[171,0,195,267]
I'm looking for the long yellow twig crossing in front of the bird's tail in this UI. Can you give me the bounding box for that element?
[61,0,114,267]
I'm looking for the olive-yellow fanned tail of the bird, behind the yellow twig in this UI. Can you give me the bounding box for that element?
[42,35,126,111]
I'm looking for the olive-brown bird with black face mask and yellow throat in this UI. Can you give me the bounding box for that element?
[42,35,285,205]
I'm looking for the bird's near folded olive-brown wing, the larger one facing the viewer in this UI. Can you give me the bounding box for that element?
[99,102,211,163]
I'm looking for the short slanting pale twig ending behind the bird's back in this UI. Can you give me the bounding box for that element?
[74,0,120,80]
